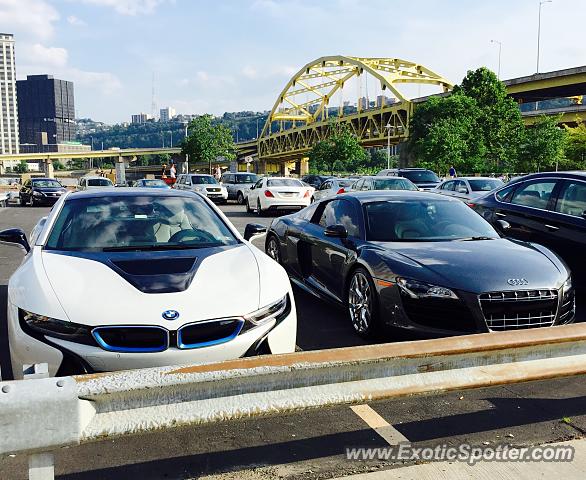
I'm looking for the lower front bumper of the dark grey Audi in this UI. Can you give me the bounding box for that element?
[377,285,575,338]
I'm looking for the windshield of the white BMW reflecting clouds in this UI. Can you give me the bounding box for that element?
[45,195,238,251]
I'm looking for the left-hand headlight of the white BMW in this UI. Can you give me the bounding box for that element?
[19,309,96,345]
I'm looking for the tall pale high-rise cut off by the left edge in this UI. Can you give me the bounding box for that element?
[0,33,19,154]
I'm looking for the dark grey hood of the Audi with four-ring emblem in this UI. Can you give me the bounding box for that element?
[378,238,568,293]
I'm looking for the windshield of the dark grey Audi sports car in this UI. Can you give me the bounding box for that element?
[365,199,499,242]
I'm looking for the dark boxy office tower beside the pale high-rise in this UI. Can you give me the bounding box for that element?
[16,75,76,151]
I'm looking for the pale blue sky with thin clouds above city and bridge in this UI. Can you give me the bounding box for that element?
[0,0,586,123]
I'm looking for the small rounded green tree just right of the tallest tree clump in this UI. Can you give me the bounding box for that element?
[519,116,567,172]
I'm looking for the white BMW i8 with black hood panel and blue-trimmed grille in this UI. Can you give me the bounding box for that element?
[0,188,297,378]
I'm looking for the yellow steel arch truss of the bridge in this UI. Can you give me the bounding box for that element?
[257,55,453,160]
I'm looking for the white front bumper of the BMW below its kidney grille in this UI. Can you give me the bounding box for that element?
[8,292,297,379]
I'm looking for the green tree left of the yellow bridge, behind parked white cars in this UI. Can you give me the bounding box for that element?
[181,115,236,171]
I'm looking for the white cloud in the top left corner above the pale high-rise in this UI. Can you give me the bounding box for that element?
[0,0,59,39]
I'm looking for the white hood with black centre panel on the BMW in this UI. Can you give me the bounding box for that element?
[42,244,260,328]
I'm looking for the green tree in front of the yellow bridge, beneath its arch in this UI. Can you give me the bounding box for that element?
[309,121,368,175]
